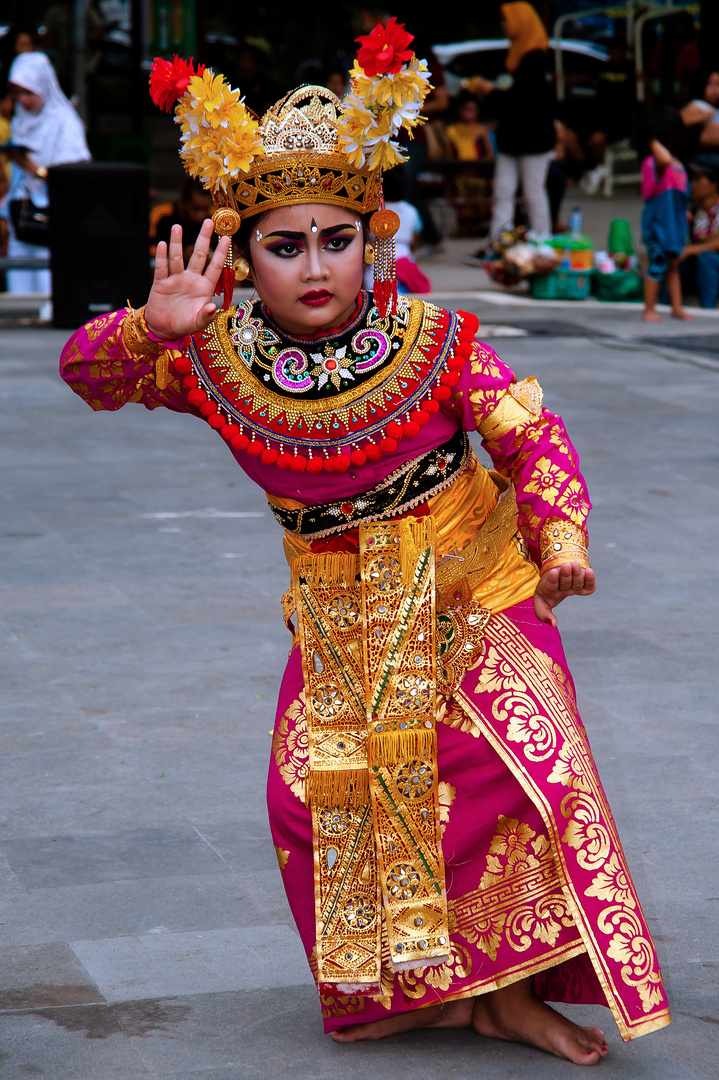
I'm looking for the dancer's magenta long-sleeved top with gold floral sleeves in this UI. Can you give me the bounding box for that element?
[60,311,591,563]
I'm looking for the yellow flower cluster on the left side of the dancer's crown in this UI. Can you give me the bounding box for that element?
[175,69,262,189]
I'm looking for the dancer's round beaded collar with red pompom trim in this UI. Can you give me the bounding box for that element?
[172,294,477,472]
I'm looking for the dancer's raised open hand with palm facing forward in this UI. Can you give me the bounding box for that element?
[145,218,230,341]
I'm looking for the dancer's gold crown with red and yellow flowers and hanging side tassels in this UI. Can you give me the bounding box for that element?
[150,18,432,316]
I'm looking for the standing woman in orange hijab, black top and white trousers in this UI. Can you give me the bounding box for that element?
[473,0,555,237]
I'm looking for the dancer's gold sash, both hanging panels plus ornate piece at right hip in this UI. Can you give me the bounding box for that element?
[286,489,516,994]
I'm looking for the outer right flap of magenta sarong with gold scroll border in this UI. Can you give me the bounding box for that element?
[458,615,671,1039]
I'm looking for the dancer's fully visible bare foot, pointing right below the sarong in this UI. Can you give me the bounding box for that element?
[472,978,608,1065]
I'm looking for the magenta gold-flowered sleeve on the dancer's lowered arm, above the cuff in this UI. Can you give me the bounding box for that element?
[453,343,592,565]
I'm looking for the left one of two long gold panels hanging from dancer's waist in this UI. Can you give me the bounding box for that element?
[291,570,381,994]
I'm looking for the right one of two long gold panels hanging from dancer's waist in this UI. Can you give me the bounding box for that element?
[360,518,449,968]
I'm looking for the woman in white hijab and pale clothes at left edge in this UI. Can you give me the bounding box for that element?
[3,53,90,293]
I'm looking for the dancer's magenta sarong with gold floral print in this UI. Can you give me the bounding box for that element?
[268,600,670,1039]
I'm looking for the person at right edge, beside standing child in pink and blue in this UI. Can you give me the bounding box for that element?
[679,158,719,308]
